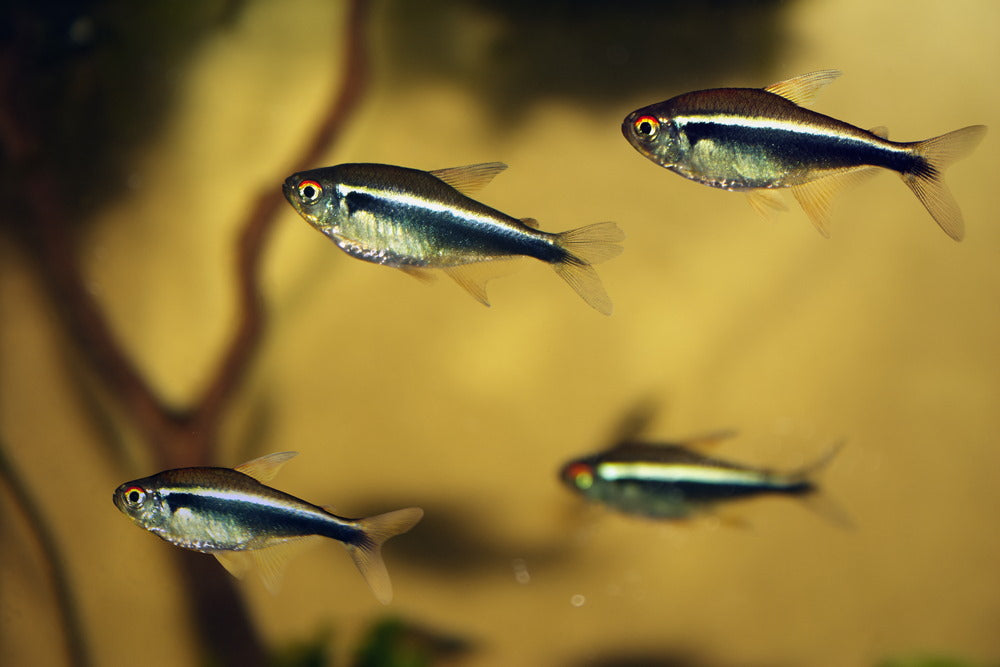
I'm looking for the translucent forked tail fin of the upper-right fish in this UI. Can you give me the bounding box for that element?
[902,125,986,241]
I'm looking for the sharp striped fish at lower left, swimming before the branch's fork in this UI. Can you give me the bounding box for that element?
[113,452,424,604]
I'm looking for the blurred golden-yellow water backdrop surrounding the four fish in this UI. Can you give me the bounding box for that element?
[0,0,1000,666]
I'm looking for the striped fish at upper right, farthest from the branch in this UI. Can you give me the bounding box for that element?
[622,70,986,241]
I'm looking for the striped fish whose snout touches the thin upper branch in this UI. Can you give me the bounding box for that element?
[283,162,625,315]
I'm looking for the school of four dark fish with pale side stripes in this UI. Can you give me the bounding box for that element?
[113,70,986,603]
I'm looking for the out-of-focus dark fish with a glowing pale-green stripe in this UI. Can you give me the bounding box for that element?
[560,432,840,521]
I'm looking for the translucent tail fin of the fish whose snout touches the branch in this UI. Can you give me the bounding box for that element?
[552,222,625,315]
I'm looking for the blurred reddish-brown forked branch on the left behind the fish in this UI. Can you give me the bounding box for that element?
[0,0,368,665]
